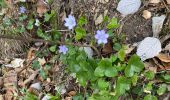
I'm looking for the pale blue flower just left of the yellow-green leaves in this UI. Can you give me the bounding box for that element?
[64,15,76,30]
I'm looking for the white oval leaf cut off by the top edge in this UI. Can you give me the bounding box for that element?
[117,0,141,16]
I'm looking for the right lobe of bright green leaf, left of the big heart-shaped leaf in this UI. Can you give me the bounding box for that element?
[105,67,118,77]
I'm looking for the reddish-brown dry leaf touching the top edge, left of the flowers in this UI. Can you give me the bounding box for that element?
[37,0,48,17]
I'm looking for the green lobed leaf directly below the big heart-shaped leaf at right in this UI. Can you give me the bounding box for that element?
[115,76,131,95]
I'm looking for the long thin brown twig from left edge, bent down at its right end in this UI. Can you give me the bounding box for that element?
[0,35,101,57]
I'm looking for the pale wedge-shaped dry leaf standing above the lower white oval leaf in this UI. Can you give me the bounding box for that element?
[152,15,166,37]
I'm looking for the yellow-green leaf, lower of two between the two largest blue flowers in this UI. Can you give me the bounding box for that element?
[75,27,86,41]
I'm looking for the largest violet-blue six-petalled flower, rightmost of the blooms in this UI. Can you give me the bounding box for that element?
[95,30,109,44]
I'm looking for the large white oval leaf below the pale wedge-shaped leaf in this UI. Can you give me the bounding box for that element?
[137,37,162,61]
